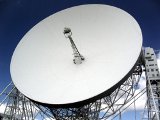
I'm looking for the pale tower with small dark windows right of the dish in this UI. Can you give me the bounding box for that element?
[144,47,160,120]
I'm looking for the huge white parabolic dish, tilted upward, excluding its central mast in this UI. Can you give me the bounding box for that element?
[10,4,142,106]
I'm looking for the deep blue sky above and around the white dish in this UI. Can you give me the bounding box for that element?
[0,0,160,119]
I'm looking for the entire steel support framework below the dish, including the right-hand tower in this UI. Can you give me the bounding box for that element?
[0,48,160,120]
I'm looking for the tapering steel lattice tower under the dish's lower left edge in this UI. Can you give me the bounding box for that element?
[4,88,39,120]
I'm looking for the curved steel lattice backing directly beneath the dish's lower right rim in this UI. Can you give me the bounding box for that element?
[37,61,142,120]
